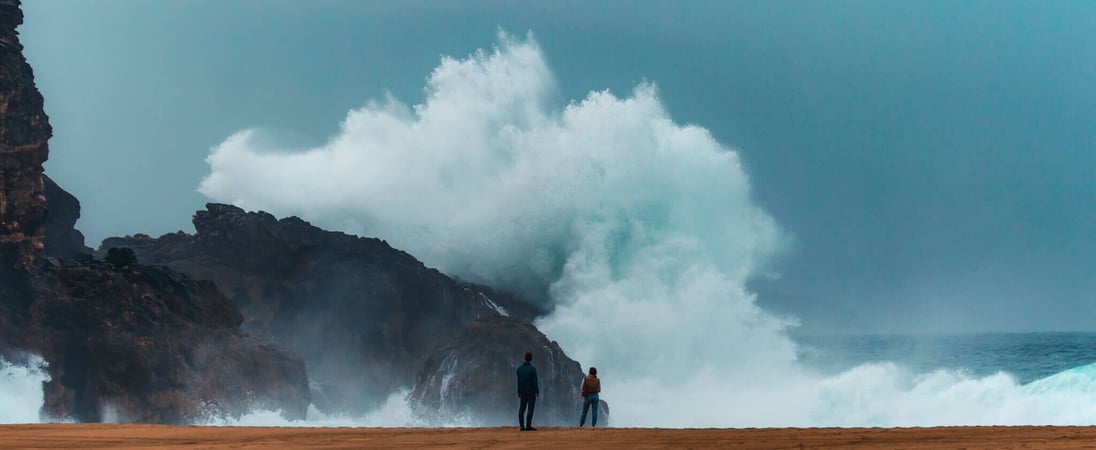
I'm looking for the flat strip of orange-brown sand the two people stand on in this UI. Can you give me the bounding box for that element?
[0,424,1096,449]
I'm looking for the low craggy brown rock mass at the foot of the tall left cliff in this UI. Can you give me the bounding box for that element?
[0,262,310,424]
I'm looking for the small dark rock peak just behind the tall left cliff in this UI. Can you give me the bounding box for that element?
[42,175,92,259]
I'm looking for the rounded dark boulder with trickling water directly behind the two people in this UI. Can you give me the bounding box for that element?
[410,316,608,426]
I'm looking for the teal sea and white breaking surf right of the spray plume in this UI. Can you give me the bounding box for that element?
[786,333,1096,427]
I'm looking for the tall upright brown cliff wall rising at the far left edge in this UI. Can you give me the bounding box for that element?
[0,0,53,269]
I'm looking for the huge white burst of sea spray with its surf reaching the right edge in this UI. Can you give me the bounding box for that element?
[199,35,1096,427]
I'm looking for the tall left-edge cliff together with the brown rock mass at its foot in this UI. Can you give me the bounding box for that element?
[0,0,309,423]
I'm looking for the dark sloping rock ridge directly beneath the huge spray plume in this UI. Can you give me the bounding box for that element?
[100,204,548,414]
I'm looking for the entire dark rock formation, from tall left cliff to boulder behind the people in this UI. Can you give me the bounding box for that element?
[0,0,600,424]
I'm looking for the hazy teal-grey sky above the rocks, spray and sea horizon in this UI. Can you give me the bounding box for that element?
[20,0,1096,333]
